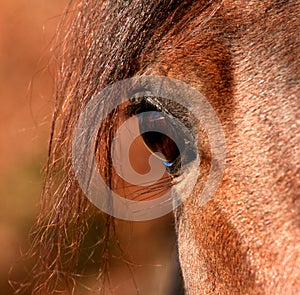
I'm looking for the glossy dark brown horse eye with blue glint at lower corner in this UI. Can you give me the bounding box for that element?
[138,111,195,174]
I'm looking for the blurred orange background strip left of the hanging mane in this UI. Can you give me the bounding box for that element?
[0,0,66,295]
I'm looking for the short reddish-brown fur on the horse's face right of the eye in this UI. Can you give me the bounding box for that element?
[170,1,300,294]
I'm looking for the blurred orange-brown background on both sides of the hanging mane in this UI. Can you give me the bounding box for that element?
[0,0,178,295]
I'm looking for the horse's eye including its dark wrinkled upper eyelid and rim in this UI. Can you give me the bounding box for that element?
[127,97,196,176]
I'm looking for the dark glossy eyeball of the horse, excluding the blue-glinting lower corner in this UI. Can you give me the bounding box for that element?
[139,112,184,163]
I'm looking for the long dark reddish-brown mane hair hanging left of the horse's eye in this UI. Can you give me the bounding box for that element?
[12,0,221,294]
